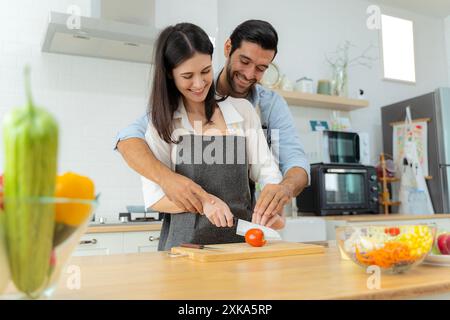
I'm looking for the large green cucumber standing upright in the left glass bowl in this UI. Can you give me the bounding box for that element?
[3,68,58,297]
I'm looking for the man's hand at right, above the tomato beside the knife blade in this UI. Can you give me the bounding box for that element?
[252,184,293,226]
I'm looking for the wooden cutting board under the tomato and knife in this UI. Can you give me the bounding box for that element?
[171,241,325,262]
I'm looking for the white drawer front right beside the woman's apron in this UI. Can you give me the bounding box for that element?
[123,231,160,253]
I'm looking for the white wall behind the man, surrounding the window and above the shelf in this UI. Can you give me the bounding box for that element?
[219,0,449,165]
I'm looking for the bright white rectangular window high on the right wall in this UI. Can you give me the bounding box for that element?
[381,14,416,83]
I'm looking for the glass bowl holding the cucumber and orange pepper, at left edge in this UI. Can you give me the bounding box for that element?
[0,197,98,299]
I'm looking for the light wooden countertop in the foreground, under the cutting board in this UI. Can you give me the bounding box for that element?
[53,247,450,300]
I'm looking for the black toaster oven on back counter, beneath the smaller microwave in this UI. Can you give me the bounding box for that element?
[296,163,379,216]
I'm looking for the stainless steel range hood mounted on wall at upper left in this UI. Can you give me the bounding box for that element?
[42,0,158,64]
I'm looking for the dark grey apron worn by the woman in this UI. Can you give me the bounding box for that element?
[158,135,253,250]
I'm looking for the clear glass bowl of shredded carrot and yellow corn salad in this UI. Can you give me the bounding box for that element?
[336,225,436,273]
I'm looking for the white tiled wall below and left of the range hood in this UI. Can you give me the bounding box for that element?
[0,0,150,221]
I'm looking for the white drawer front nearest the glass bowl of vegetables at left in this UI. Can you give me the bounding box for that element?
[73,233,123,256]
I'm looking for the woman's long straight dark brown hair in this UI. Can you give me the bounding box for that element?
[148,23,217,143]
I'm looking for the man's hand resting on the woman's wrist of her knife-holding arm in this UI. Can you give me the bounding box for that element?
[160,172,215,212]
